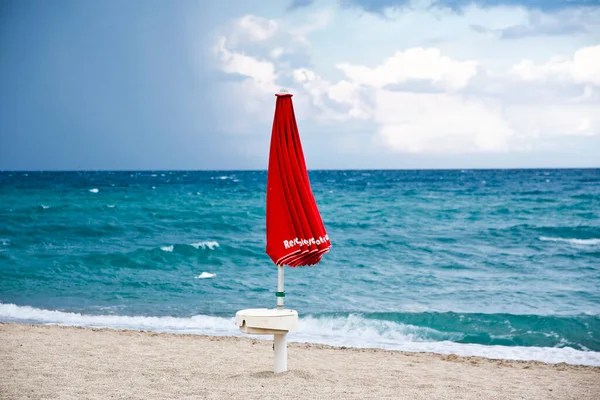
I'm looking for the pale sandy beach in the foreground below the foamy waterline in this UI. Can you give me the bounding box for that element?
[0,324,600,399]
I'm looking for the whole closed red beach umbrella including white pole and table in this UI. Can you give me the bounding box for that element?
[236,89,331,373]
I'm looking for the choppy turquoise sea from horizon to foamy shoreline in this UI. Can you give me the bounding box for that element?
[0,169,600,365]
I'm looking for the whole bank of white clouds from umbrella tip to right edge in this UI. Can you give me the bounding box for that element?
[214,2,600,161]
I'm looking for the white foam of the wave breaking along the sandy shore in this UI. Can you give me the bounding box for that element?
[0,304,600,366]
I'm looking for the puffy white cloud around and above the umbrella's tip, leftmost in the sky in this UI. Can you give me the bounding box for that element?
[213,10,330,134]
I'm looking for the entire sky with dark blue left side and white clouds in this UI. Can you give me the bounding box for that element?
[0,0,600,170]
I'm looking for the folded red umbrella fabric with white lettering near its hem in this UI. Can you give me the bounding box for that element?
[267,94,331,267]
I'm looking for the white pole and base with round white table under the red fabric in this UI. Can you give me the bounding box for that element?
[235,267,298,374]
